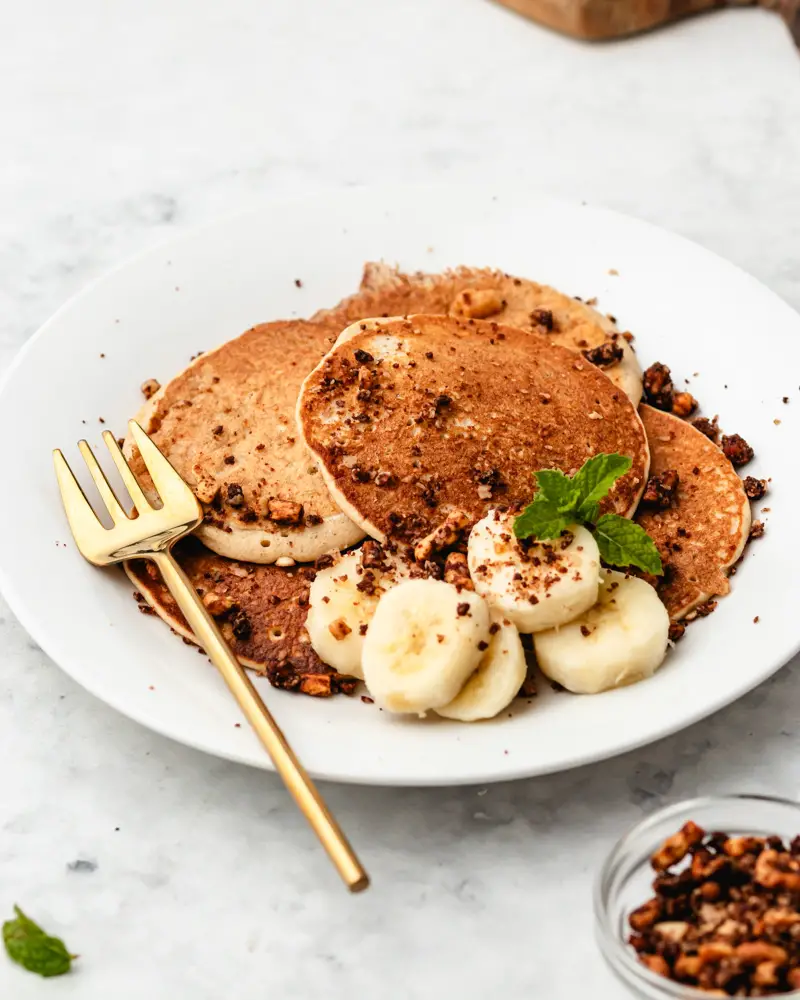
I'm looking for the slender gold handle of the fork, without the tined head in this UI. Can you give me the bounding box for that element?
[152,550,369,892]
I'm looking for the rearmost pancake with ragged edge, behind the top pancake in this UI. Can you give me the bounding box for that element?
[314,264,642,405]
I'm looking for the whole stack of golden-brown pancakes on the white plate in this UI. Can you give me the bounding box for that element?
[126,264,750,695]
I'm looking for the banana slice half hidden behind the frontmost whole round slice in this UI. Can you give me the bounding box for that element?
[436,611,528,722]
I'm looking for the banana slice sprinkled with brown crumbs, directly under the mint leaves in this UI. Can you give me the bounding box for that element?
[467,510,600,632]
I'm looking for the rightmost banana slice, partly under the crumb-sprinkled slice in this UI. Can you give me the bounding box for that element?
[533,570,669,694]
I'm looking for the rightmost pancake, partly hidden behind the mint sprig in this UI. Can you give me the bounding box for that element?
[636,406,750,619]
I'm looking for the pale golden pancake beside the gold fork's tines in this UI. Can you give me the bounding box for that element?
[125,320,362,563]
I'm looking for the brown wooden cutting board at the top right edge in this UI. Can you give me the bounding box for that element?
[498,0,800,44]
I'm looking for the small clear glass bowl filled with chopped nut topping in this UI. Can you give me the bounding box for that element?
[594,795,800,1000]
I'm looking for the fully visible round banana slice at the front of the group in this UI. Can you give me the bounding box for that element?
[362,579,491,715]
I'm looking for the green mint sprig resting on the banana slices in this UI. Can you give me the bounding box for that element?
[514,453,664,576]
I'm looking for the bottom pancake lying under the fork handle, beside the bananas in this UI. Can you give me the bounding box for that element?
[125,537,355,695]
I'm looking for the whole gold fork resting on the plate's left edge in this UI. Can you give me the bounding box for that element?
[53,420,369,892]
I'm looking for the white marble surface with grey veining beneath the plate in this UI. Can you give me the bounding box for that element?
[0,0,800,1000]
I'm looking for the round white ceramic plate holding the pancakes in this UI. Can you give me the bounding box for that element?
[0,187,800,785]
